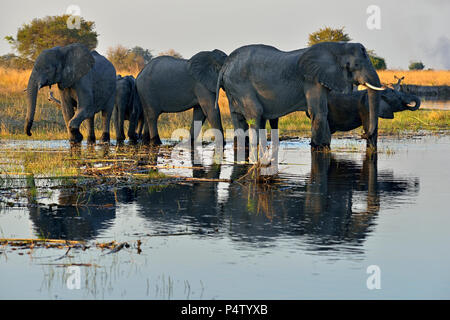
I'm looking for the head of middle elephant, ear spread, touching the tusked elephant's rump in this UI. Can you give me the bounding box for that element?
[188,49,227,92]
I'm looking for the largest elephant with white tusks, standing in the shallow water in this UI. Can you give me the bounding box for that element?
[216,42,381,150]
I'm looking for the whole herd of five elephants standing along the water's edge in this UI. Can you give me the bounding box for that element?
[25,42,420,150]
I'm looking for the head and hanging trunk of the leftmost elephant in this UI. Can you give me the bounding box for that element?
[25,43,94,136]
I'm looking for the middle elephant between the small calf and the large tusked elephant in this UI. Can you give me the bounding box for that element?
[136,50,226,145]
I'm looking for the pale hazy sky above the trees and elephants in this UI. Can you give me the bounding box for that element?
[0,0,450,69]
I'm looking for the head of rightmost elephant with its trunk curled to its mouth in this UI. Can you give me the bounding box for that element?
[379,88,420,119]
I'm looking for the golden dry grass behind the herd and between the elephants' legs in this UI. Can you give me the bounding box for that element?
[0,67,450,140]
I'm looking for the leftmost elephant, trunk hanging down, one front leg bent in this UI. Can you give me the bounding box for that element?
[25,43,116,143]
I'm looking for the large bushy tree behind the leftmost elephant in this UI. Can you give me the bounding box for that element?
[5,15,98,60]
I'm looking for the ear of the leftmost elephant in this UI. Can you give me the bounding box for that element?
[59,43,95,89]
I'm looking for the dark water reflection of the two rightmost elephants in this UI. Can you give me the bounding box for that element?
[224,152,418,244]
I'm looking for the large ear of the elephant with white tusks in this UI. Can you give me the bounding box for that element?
[298,43,348,92]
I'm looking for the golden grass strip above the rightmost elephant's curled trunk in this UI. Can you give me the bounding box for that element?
[378,70,450,86]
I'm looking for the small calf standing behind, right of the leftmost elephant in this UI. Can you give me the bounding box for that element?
[114,75,144,143]
